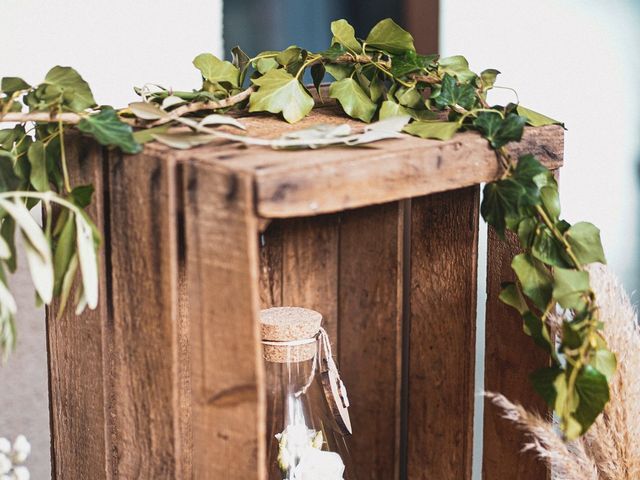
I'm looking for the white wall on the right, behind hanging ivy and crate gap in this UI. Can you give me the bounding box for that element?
[441,0,640,478]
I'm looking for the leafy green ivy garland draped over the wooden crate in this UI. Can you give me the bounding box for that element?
[0,19,616,439]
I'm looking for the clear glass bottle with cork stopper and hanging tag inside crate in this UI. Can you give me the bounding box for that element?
[261,307,357,480]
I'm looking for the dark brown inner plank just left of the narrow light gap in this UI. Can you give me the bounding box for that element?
[407,186,478,480]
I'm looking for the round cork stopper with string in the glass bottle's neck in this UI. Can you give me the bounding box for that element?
[260,307,322,363]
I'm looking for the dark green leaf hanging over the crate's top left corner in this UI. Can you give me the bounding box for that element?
[78,108,142,153]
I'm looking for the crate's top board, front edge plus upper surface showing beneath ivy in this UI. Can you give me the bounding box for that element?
[146,100,564,218]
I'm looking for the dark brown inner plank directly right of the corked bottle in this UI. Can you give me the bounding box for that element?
[338,203,404,480]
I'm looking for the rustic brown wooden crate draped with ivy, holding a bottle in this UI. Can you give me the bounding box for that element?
[48,104,563,480]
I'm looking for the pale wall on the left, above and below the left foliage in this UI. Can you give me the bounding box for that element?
[0,0,222,480]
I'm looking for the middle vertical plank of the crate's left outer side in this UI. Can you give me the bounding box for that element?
[108,149,182,478]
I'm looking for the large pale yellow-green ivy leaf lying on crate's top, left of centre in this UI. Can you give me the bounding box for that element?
[249,69,314,123]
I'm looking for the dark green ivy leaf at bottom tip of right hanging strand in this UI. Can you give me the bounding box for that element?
[569,365,609,440]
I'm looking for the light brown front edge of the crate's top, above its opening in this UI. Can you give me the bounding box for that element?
[252,126,563,217]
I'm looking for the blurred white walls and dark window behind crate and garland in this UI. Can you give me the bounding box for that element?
[0,0,640,479]
